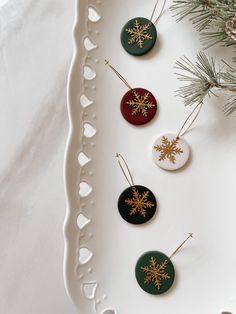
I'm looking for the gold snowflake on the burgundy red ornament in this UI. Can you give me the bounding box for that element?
[127,90,156,117]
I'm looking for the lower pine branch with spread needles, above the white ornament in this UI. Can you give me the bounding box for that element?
[175,52,236,115]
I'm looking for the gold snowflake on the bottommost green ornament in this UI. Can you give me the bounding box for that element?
[141,257,170,290]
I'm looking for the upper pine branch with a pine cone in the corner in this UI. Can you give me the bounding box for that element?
[171,0,236,49]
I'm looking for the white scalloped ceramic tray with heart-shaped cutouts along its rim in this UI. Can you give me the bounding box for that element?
[64,0,236,314]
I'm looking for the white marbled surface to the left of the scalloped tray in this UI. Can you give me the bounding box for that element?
[0,0,74,314]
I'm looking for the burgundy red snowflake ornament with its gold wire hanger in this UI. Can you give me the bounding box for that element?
[105,60,157,125]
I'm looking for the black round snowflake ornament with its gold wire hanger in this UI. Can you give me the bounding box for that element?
[116,154,157,225]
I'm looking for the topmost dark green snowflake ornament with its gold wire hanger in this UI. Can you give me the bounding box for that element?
[120,1,166,56]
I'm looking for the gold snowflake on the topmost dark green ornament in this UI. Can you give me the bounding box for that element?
[125,20,152,49]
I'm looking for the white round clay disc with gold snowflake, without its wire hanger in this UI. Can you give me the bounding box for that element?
[152,134,190,170]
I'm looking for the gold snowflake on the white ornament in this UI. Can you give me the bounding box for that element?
[154,136,183,164]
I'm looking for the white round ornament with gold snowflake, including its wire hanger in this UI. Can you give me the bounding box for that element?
[152,103,202,171]
